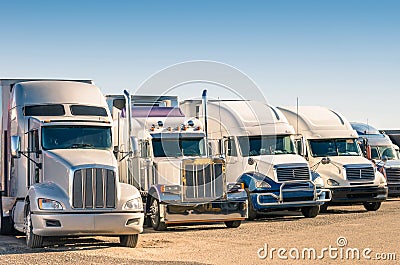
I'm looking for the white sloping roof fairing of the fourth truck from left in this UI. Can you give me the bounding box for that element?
[278,106,358,139]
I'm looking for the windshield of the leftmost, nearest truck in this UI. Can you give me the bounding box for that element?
[42,126,111,150]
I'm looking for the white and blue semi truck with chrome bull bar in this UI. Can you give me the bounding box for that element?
[181,100,330,220]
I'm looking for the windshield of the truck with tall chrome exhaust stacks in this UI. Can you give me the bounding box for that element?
[152,137,205,157]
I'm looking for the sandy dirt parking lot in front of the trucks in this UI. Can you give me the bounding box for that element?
[0,199,400,264]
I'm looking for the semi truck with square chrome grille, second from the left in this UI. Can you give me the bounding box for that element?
[106,91,247,230]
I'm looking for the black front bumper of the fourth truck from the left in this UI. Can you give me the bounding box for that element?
[328,186,388,205]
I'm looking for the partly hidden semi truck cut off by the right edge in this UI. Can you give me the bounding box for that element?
[351,122,400,197]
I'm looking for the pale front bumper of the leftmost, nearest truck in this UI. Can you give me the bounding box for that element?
[32,212,144,236]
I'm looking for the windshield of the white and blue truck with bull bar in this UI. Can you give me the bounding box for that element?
[238,135,296,156]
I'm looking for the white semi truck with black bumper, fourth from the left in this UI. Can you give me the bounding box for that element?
[279,106,388,211]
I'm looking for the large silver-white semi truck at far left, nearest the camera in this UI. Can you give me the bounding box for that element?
[0,79,144,248]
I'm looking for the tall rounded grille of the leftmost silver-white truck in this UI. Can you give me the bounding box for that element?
[72,168,116,209]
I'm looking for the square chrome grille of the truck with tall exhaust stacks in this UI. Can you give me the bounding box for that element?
[183,159,226,201]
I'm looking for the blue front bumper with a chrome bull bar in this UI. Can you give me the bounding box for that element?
[250,189,331,211]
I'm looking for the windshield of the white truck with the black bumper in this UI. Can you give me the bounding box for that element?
[310,139,361,156]
